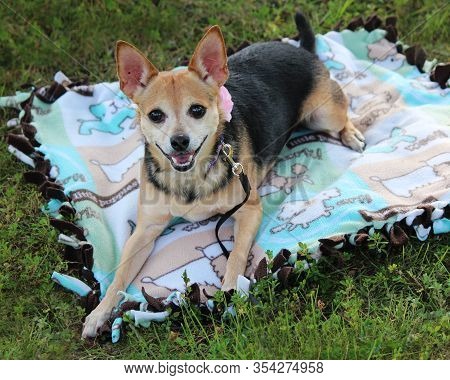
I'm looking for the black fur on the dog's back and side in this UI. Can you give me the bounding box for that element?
[225,37,323,164]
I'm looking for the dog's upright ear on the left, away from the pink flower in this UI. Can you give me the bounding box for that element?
[116,41,158,99]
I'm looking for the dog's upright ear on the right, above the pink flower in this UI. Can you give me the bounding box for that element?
[189,25,228,87]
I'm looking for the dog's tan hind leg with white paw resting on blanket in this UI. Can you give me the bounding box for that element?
[302,76,366,152]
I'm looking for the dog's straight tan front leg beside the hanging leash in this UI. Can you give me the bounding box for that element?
[222,194,262,291]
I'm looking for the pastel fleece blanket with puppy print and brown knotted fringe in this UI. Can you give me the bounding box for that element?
[0,23,450,338]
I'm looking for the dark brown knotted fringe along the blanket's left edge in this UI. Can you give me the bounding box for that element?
[6,82,100,315]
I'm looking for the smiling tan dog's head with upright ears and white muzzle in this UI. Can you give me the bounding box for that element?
[116,26,228,172]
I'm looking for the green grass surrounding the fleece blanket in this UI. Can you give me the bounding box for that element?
[0,0,450,359]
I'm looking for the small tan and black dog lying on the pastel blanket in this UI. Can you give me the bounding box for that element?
[82,13,365,338]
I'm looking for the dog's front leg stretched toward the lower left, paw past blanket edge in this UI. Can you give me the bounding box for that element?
[82,208,170,339]
